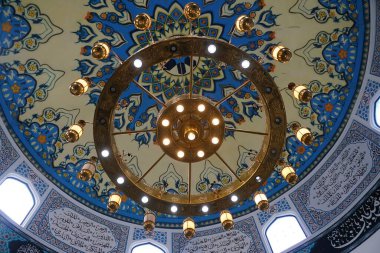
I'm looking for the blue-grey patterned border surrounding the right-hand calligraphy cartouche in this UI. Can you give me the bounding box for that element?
[289,121,380,233]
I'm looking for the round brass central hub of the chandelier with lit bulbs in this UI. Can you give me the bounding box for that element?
[157,95,225,163]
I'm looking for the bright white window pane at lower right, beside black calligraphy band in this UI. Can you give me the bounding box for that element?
[266,215,306,253]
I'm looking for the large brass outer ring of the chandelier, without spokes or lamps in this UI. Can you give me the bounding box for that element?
[93,36,287,216]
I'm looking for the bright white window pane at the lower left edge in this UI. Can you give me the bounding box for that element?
[0,177,35,225]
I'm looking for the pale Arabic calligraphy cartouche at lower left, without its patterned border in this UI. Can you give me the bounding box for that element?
[48,208,117,253]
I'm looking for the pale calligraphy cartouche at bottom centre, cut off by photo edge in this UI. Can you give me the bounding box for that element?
[182,230,251,253]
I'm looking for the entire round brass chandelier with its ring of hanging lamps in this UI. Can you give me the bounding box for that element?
[66,3,313,238]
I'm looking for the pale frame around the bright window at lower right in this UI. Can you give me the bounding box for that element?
[262,211,311,252]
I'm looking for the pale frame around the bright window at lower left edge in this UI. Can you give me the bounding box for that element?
[0,173,40,227]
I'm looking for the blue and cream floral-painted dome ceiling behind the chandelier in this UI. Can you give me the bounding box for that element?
[0,0,368,227]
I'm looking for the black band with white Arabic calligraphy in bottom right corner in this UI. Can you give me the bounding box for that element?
[327,189,380,248]
